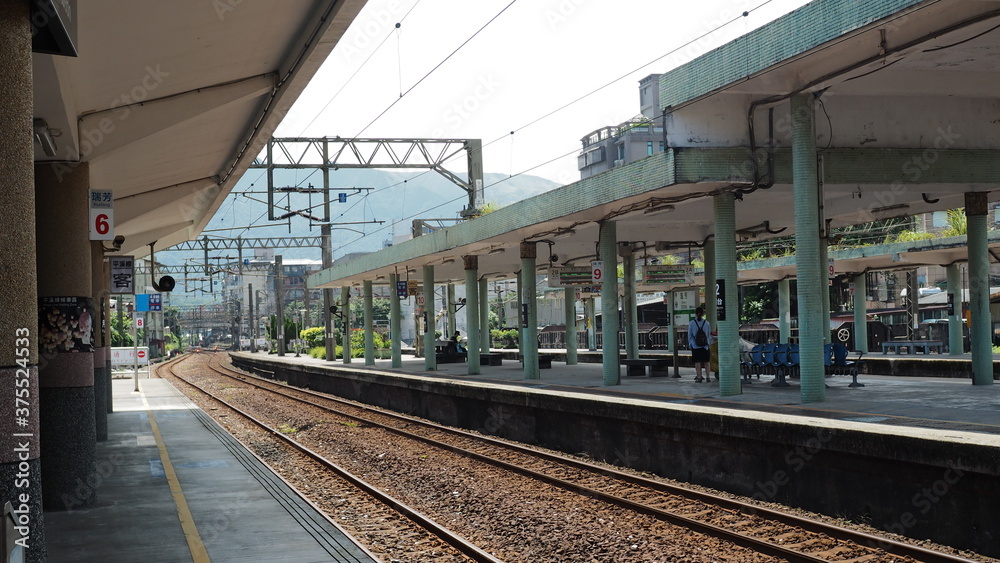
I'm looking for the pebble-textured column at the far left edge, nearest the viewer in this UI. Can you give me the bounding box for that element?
[0,0,44,563]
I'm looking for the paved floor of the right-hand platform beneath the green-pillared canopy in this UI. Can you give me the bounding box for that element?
[256,350,1000,438]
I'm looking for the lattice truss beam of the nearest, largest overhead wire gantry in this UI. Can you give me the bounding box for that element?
[250,137,483,222]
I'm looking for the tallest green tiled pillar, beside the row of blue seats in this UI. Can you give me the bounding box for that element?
[791,94,830,403]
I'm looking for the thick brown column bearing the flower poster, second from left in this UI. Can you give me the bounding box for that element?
[35,163,103,510]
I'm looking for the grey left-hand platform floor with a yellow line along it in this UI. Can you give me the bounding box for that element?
[45,378,376,563]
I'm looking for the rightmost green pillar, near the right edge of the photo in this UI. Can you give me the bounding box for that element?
[965,192,993,385]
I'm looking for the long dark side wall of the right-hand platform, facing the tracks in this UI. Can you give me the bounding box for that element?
[233,355,1000,557]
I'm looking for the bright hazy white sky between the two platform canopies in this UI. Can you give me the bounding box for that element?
[275,0,807,191]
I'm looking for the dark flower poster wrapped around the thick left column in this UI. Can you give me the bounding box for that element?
[38,297,94,354]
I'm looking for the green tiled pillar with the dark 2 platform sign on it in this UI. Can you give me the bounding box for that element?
[705,193,743,397]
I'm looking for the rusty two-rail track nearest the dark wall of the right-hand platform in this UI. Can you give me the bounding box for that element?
[170,357,984,563]
